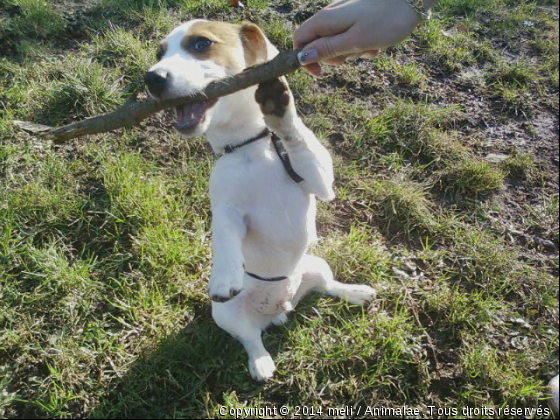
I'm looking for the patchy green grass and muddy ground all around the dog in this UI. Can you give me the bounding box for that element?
[0,0,559,418]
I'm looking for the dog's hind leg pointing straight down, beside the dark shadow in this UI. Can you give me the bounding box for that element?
[212,295,276,382]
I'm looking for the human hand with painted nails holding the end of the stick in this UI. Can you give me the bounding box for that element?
[294,0,420,76]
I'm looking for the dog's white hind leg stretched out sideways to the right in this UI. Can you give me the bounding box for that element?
[293,255,377,307]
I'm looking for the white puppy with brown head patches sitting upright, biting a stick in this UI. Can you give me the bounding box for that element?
[145,20,376,381]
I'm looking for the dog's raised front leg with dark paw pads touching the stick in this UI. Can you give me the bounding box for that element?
[255,77,334,200]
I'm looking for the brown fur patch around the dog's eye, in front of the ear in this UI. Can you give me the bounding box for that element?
[181,22,243,70]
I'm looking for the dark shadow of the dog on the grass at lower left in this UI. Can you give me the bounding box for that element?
[91,307,254,418]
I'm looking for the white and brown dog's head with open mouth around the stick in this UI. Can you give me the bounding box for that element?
[145,20,278,137]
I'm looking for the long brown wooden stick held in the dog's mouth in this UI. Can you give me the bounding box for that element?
[14,50,301,144]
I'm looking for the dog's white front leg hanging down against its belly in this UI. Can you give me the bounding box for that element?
[208,205,247,302]
